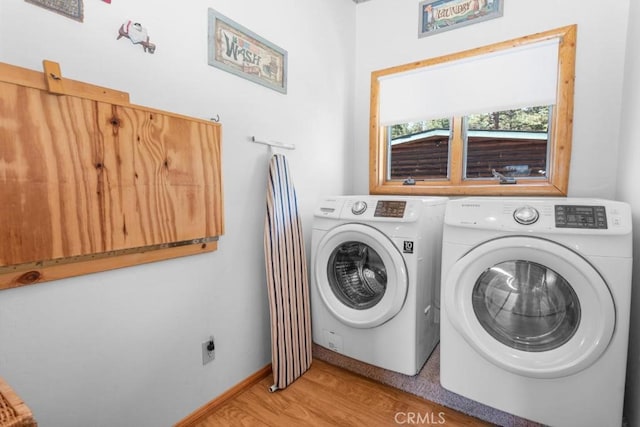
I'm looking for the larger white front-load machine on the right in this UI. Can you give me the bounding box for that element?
[440,197,632,427]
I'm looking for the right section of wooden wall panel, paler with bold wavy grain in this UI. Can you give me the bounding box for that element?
[98,104,222,250]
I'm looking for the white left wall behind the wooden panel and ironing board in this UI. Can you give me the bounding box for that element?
[0,0,356,427]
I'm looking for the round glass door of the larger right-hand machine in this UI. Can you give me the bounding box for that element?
[442,236,615,378]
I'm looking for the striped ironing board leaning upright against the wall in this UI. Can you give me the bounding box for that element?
[264,154,312,391]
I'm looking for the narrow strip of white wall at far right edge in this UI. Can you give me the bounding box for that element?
[617,2,640,426]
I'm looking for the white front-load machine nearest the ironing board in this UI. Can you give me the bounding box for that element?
[311,196,447,375]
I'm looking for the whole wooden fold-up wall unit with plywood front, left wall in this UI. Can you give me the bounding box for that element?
[0,63,224,289]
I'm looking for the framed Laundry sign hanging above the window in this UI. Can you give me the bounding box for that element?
[418,0,504,37]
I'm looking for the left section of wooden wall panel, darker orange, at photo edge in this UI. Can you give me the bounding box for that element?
[0,82,105,265]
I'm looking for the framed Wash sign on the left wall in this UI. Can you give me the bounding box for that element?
[209,9,287,93]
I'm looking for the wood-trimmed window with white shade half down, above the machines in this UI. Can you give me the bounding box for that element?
[369,25,576,196]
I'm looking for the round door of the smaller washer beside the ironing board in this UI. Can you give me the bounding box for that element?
[313,224,408,328]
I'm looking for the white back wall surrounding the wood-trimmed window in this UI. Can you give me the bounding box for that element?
[351,0,629,198]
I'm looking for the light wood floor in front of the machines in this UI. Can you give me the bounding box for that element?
[197,360,491,427]
